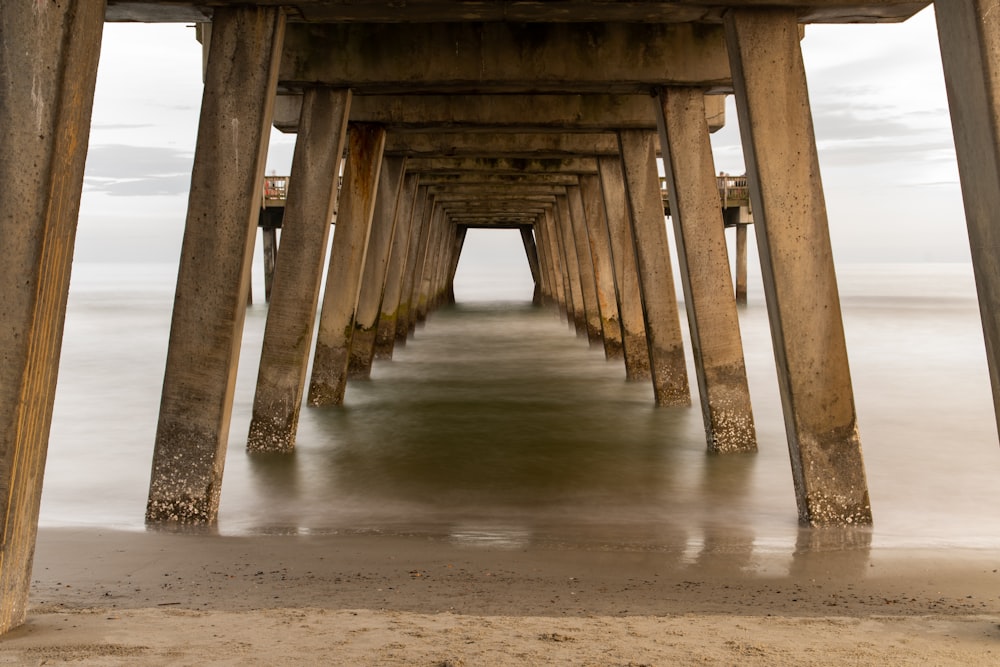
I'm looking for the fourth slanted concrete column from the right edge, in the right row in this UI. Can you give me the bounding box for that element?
[618,130,691,405]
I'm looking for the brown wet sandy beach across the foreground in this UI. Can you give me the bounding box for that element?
[0,529,1000,666]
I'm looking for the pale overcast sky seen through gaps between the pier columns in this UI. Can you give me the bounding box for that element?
[76,8,969,264]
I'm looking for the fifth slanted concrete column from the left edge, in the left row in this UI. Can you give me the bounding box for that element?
[347,156,406,378]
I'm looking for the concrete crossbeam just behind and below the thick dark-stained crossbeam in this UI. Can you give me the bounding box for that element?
[274,94,725,134]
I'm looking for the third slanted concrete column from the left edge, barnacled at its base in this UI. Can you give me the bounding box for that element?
[247,88,351,452]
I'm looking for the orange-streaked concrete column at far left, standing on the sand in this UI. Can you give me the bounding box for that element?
[0,0,104,634]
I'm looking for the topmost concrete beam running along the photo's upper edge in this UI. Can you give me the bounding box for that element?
[105,0,930,23]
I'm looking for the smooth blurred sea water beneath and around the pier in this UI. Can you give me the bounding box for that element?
[41,248,1000,551]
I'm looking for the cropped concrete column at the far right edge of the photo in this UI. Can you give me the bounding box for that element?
[934,0,1000,444]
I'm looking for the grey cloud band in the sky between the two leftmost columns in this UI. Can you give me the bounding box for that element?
[84,144,194,197]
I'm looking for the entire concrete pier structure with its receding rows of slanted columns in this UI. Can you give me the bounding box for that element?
[0,0,1000,631]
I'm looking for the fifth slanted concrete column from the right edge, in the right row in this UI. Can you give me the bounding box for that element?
[597,157,652,381]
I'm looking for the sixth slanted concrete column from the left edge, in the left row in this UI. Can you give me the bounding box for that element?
[375,174,420,359]
